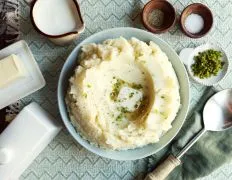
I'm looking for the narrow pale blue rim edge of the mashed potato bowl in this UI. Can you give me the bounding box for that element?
[57,27,190,161]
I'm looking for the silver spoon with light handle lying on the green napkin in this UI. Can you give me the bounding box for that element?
[145,89,232,180]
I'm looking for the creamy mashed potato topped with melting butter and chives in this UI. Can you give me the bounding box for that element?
[66,38,180,150]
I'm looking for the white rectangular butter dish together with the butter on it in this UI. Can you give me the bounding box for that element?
[0,40,46,109]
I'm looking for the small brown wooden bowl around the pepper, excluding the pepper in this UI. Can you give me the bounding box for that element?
[142,0,176,34]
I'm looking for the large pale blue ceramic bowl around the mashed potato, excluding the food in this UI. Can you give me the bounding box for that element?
[58,28,189,160]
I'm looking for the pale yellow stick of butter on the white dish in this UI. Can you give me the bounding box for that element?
[0,54,26,88]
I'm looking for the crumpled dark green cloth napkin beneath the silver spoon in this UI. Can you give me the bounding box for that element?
[148,88,232,180]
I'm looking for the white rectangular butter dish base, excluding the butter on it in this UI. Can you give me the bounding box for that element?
[0,40,45,109]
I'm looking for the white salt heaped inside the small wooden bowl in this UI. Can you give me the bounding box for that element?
[184,13,204,34]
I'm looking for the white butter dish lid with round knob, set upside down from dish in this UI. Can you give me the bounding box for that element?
[0,103,61,180]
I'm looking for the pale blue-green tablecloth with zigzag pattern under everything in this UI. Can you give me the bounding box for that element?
[15,0,232,180]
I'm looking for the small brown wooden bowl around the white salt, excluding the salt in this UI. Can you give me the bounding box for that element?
[180,3,213,38]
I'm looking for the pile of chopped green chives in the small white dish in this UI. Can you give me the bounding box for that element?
[191,49,224,79]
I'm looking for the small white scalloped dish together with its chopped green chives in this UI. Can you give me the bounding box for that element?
[180,44,229,86]
